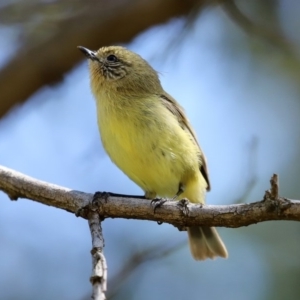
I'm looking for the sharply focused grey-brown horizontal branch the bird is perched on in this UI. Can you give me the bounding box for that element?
[0,166,300,228]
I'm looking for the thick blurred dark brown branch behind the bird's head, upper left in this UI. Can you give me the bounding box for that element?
[0,0,202,118]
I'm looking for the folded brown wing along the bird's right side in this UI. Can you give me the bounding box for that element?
[160,93,210,191]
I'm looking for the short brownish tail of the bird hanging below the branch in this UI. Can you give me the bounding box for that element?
[187,226,228,260]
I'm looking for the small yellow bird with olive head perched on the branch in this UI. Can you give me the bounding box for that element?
[78,46,228,260]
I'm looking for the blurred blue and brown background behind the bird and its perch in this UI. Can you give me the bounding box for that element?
[0,0,300,300]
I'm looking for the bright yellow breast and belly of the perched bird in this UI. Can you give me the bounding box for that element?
[97,95,198,196]
